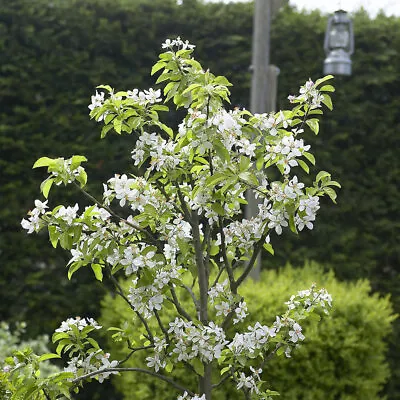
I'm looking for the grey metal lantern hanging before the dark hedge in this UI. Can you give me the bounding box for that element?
[324,10,354,75]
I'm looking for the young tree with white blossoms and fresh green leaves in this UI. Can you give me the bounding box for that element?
[14,38,339,400]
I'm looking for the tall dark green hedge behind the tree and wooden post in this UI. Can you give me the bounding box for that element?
[0,0,400,399]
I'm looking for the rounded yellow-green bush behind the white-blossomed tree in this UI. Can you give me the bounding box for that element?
[102,263,395,400]
